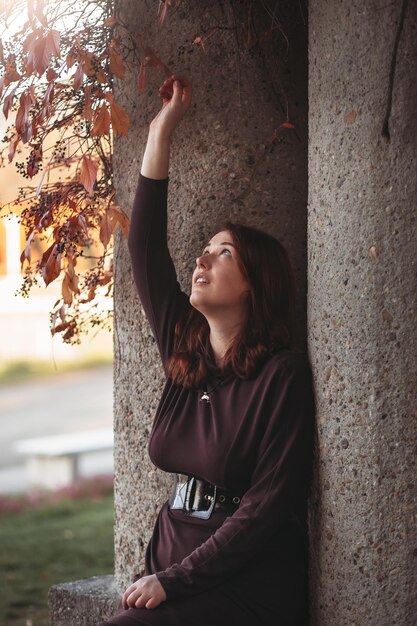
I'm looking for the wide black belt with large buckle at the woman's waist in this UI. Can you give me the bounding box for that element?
[168,474,241,519]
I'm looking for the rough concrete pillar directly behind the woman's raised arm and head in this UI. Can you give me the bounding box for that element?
[114,0,307,588]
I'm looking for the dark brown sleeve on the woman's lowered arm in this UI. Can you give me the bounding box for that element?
[156,355,314,599]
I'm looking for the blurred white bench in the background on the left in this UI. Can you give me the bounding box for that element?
[14,429,113,489]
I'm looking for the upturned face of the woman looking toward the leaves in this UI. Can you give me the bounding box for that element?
[190,230,249,320]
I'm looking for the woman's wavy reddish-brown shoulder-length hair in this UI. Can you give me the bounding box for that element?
[168,222,295,389]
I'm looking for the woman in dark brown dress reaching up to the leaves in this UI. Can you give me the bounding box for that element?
[103,76,314,626]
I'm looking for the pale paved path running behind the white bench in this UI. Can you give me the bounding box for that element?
[0,366,113,493]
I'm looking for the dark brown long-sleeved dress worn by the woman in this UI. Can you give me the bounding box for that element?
[98,176,314,626]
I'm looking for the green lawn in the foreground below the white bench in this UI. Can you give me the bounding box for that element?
[0,495,113,626]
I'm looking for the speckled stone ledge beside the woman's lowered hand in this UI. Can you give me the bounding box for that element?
[49,576,120,626]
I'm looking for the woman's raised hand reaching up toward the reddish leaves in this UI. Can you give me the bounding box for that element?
[150,74,191,141]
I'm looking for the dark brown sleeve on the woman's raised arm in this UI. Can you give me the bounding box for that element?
[128,175,190,369]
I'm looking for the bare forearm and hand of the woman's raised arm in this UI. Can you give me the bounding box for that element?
[141,75,191,180]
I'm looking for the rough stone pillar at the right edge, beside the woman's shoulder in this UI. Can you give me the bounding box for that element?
[308,0,417,626]
